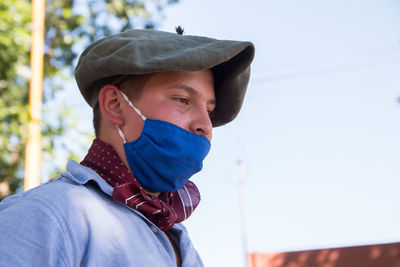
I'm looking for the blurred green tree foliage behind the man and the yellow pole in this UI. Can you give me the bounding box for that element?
[0,0,179,199]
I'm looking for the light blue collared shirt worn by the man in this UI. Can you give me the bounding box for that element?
[0,161,203,267]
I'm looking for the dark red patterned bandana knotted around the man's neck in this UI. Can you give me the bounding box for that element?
[81,139,200,231]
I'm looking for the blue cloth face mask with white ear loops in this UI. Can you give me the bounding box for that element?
[117,92,211,192]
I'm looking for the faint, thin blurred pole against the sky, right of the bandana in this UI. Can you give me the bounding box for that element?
[237,160,248,267]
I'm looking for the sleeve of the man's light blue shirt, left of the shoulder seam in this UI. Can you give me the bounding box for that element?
[0,178,79,266]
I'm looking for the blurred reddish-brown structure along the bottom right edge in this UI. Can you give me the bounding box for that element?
[248,243,400,267]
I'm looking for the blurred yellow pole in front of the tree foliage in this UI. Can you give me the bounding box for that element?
[24,0,45,193]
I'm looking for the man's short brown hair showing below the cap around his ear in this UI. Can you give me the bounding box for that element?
[93,74,153,138]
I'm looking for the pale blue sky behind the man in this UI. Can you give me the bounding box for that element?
[46,0,400,267]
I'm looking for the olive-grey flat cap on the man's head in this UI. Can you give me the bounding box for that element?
[75,30,254,127]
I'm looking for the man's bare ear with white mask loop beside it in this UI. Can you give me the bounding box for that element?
[99,84,124,127]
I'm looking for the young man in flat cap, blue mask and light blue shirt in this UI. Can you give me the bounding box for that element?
[0,30,254,266]
